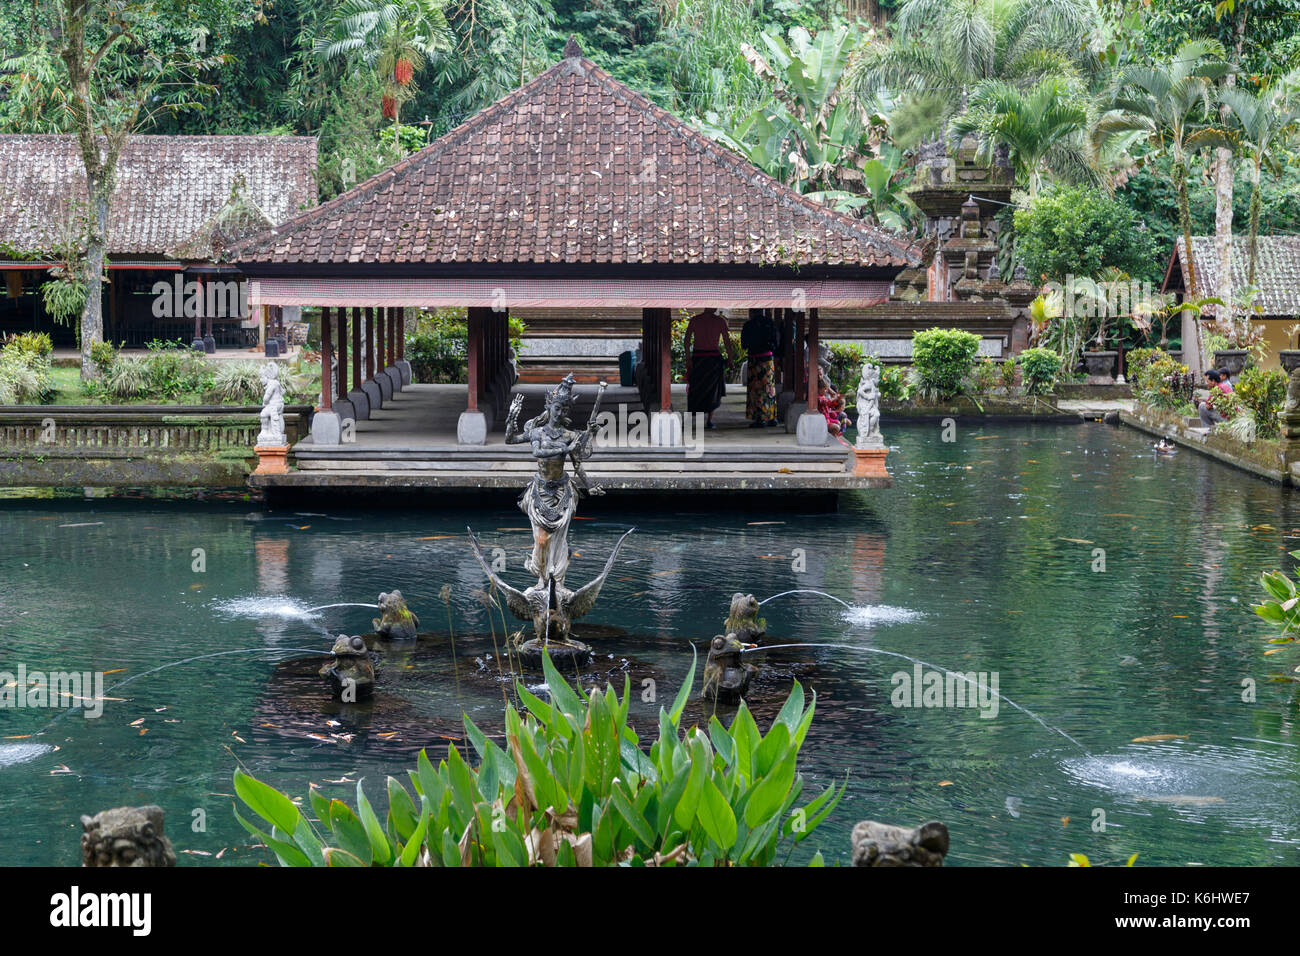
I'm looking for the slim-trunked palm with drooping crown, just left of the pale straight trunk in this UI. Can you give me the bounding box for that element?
[1092,40,1226,297]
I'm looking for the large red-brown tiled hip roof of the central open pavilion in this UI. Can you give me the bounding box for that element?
[231,47,920,276]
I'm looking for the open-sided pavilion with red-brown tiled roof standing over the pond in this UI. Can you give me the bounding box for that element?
[231,40,924,502]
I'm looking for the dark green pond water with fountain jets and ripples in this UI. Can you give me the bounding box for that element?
[0,424,1300,865]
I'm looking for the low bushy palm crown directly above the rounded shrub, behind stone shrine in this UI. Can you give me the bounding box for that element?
[950,77,1097,196]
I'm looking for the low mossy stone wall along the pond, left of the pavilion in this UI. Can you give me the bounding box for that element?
[0,405,312,488]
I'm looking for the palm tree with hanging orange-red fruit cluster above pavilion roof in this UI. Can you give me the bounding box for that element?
[315,0,451,126]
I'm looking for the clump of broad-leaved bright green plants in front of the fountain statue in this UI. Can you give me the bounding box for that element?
[234,657,846,866]
